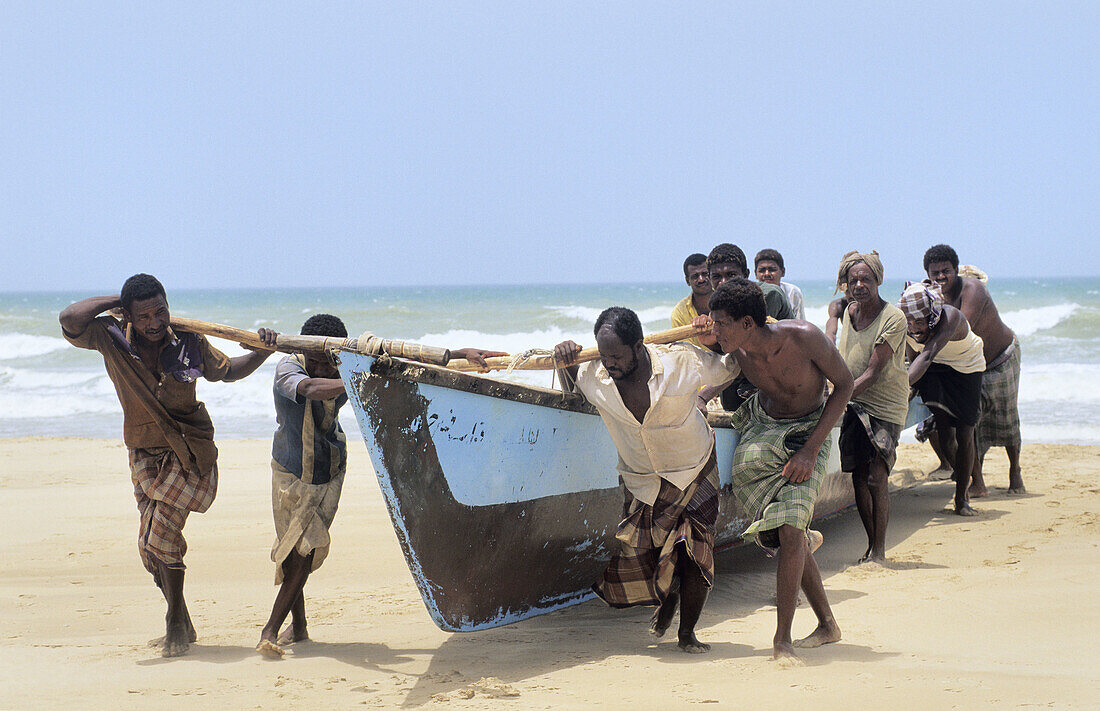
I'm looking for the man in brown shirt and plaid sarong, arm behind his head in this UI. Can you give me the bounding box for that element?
[58,274,277,657]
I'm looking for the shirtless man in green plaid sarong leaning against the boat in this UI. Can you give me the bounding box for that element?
[699,278,854,660]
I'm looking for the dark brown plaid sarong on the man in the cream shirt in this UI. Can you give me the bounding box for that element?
[592,449,719,608]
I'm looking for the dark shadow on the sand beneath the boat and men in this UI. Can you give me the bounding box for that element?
[297,471,1004,708]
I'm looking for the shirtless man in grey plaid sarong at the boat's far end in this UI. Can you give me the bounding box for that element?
[924,244,1025,497]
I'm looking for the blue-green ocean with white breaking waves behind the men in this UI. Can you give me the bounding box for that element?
[0,277,1100,445]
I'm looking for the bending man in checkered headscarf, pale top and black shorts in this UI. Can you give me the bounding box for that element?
[898,280,986,516]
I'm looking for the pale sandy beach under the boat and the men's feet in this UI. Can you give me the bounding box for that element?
[0,438,1100,711]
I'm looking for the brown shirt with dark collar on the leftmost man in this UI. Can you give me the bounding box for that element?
[62,316,229,475]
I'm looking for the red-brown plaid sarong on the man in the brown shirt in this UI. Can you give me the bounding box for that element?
[130,447,218,577]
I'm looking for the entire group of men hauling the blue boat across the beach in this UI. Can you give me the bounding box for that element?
[59,244,1023,658]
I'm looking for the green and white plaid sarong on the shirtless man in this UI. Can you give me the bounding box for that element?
[730,393,833,542]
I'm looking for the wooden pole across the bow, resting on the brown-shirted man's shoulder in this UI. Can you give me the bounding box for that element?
[172,316,451,365]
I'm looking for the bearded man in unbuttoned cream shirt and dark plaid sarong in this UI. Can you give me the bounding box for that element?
[554,307,738,654]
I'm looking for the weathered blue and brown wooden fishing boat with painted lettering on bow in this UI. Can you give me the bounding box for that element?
[339,352,928,632]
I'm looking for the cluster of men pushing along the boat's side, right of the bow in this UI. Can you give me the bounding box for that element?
[554,244,1023,659]
